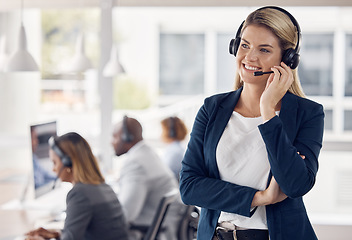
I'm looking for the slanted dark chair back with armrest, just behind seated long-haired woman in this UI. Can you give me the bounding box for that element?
[130,190,178,240]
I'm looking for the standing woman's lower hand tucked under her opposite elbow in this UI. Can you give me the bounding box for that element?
[252,177,287,207]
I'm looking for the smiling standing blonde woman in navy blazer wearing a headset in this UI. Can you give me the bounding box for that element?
[180,7,324,240]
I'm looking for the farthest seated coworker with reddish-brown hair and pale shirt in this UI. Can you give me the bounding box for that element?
[161,117,187,180]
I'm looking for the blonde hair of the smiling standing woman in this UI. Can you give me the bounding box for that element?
[234,8,305,97]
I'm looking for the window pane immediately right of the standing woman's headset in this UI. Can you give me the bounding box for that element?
[298,34,333,96]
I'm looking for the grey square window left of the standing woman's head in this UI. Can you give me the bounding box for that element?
[159,34,204,95]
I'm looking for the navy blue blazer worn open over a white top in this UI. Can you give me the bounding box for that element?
[180,88,324,240]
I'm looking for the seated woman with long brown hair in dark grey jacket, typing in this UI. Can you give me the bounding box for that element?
[27,132,128,240]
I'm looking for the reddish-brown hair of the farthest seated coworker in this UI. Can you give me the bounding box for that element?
[161,117,188,141]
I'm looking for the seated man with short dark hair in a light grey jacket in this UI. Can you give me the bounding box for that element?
[112,116,178,240]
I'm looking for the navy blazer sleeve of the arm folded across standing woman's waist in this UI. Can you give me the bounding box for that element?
[180,97,257,217]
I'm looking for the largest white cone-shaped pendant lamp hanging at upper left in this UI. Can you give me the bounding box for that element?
[5,0,39,72]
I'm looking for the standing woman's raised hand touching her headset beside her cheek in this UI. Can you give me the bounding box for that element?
[260,62,293,121]
